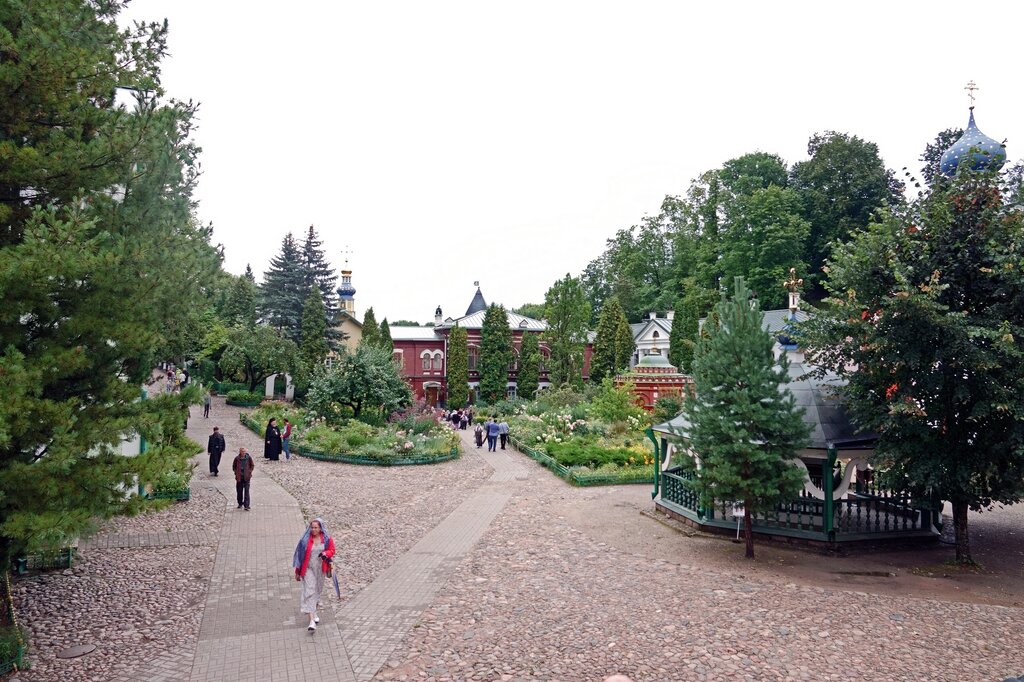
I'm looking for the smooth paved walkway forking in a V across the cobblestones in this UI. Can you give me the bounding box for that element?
[154,400,529,682]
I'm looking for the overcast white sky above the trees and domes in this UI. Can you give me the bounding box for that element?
[125,0,1024,322]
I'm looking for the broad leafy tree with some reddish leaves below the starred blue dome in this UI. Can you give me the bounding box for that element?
[807,169,1024,562]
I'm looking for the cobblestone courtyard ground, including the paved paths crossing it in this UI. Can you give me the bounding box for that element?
[8,393,1024,682]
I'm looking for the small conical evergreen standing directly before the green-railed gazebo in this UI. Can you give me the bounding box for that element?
[683,278,810,559]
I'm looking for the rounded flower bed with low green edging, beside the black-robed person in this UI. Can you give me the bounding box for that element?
[239,409,460,466]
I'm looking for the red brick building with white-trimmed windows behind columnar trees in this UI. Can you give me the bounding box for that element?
[390,288,593,404]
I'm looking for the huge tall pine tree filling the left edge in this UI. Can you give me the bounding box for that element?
[0,0,219,573]
